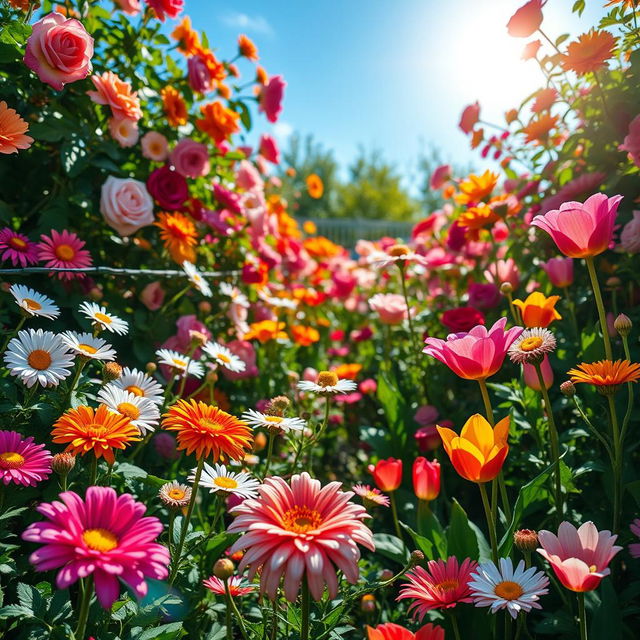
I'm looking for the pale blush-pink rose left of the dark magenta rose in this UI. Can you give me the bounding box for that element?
[100,176,153,236]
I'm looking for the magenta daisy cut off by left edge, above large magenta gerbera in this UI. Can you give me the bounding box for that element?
[0,431,51,487]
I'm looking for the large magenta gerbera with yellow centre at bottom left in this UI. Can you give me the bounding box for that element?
[22,487,170,609]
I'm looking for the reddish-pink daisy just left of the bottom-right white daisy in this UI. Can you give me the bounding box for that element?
[397,556,478,620]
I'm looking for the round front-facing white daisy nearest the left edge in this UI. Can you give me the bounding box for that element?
[4,329,74,388]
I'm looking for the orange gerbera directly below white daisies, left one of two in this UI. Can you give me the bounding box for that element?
[51,404,141,464]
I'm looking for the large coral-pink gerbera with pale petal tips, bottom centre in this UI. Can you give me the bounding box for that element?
[228,473,375,602]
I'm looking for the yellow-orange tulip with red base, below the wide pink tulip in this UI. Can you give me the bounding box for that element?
[437,413,509,482]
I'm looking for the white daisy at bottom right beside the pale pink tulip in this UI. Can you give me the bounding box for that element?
[469,558,549,618]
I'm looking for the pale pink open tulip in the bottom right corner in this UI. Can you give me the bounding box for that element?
[538,522,622,593]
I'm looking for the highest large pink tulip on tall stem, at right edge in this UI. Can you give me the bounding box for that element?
[531,193,622,258]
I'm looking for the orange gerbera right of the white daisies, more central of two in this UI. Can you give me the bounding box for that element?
[162,400,253,462]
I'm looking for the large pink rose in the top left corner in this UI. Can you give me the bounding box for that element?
[24,13,93,91]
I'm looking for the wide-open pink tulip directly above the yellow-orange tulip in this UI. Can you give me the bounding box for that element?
[423,318,524,380]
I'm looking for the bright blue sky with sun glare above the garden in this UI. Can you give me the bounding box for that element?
[186,0,604,181]
